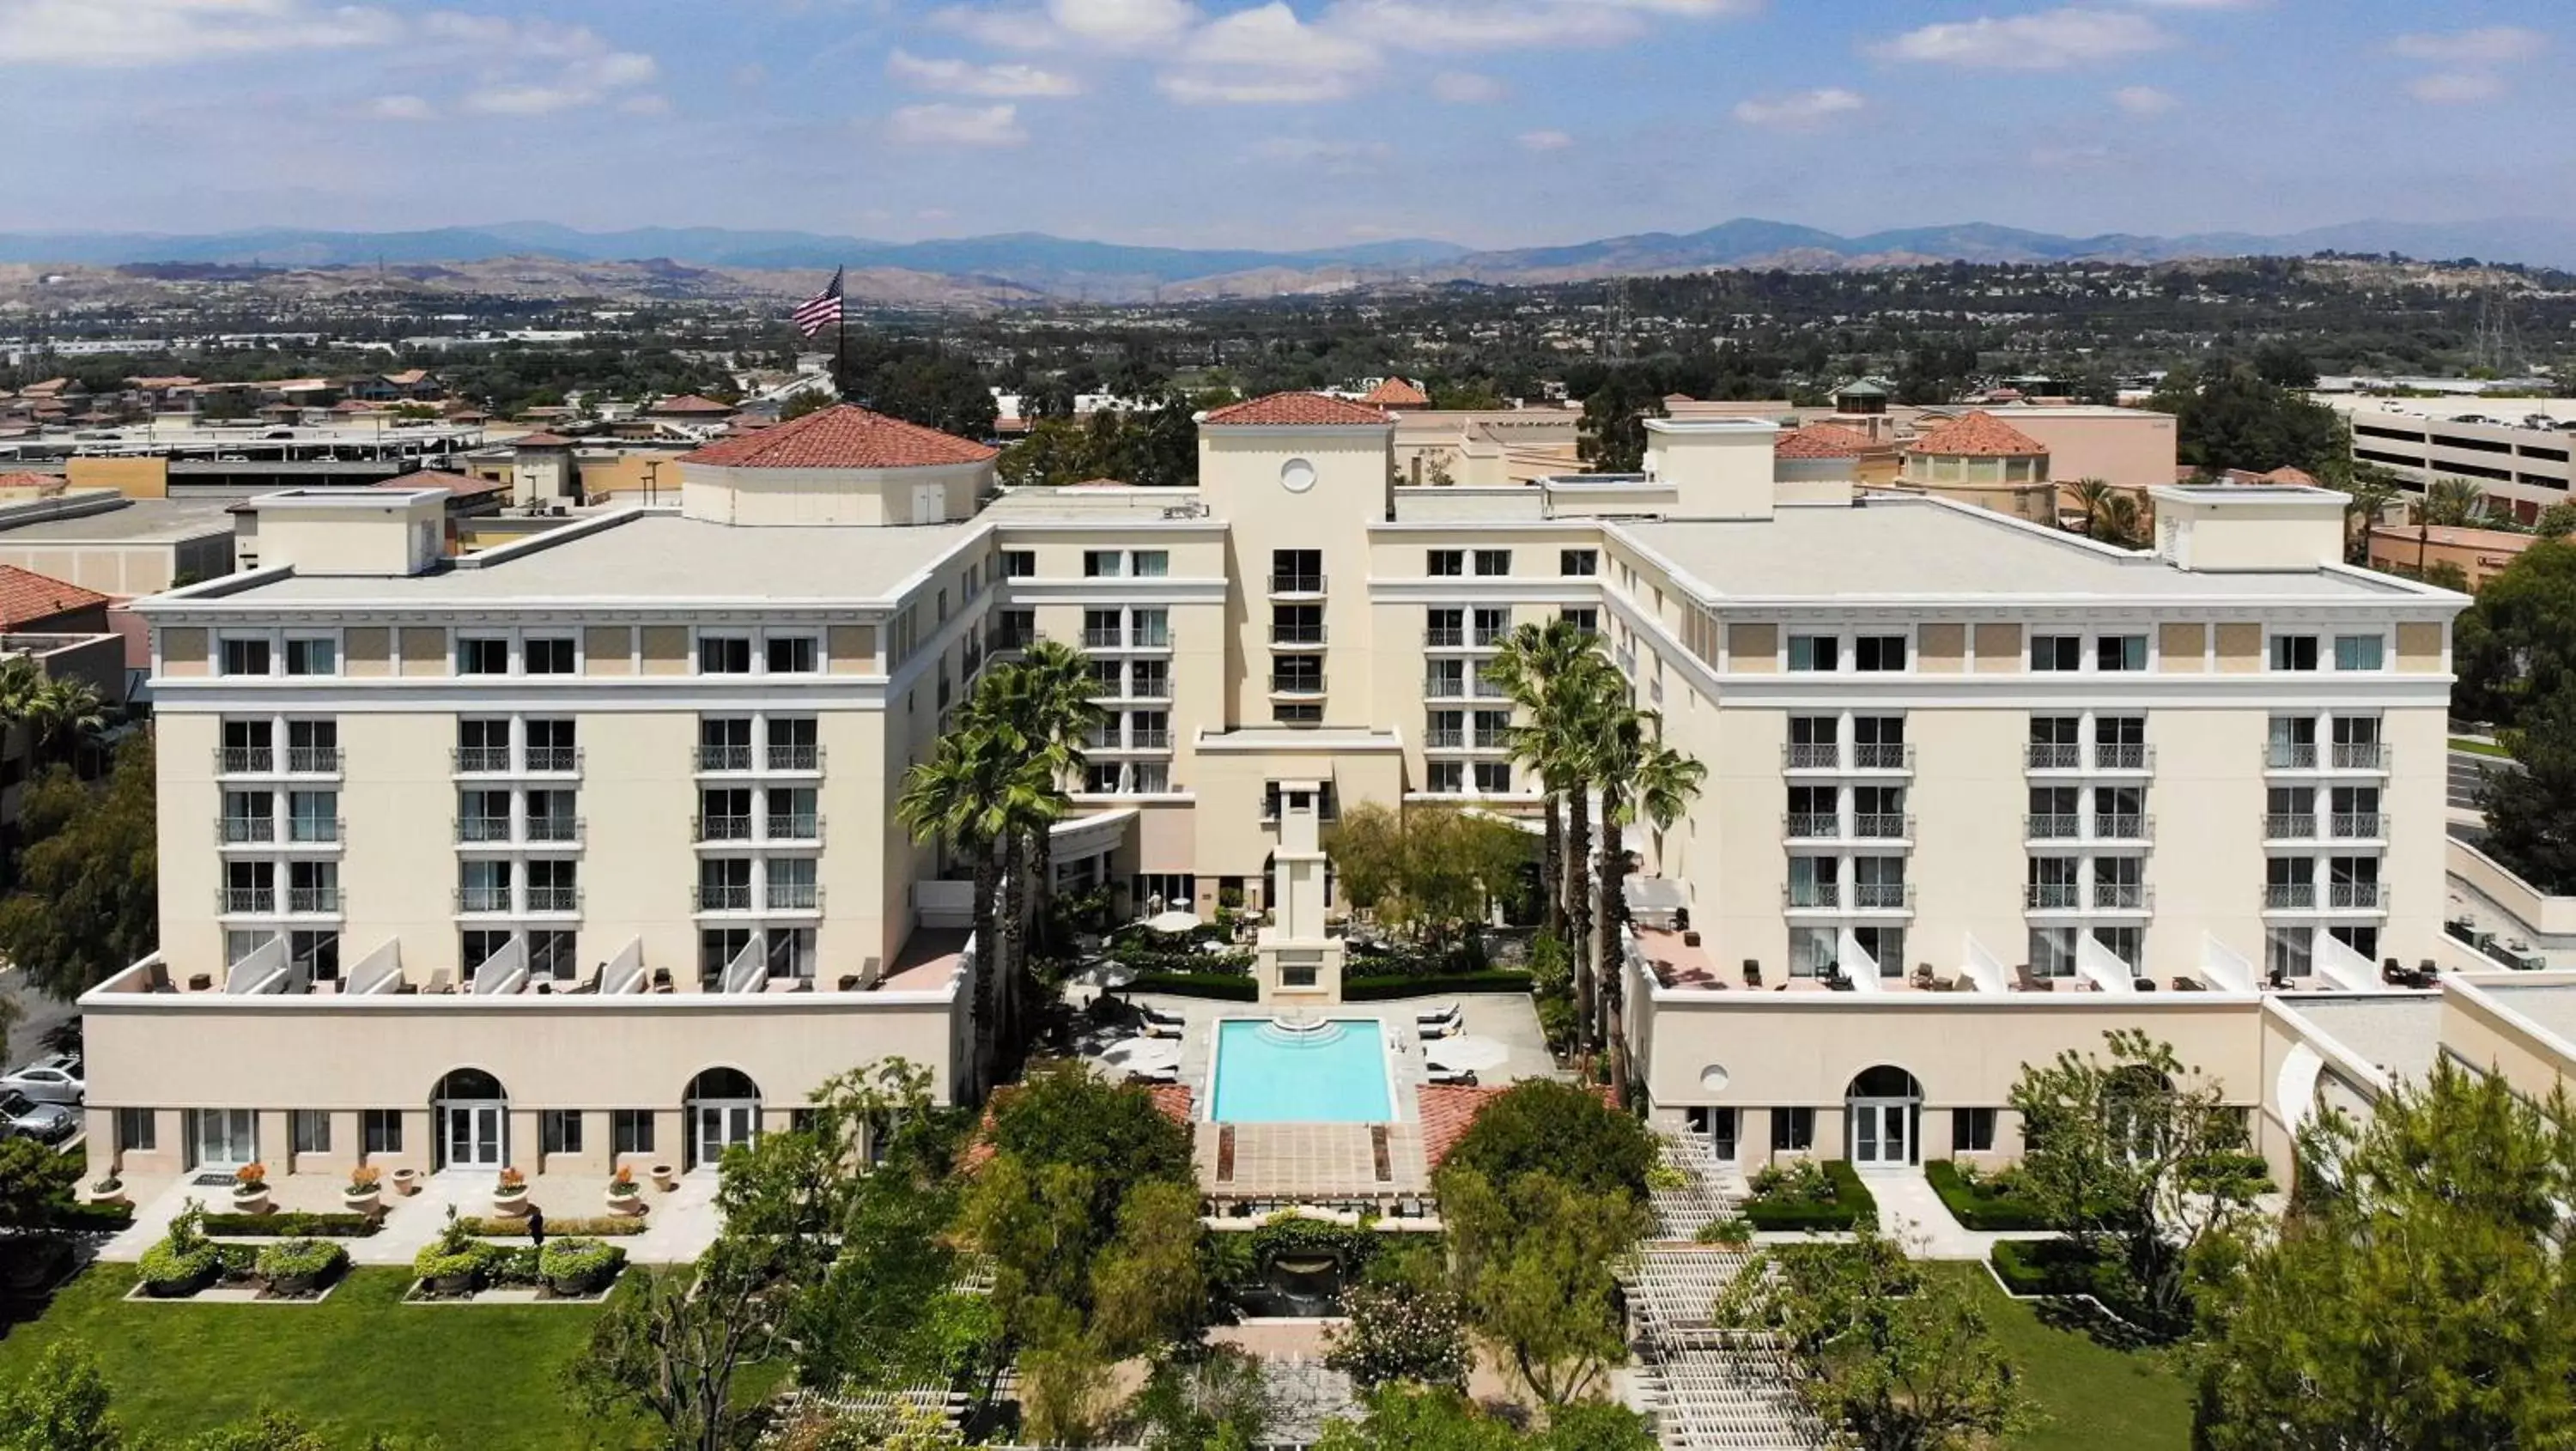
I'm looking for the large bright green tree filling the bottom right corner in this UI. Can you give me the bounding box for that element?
[2195,1062,2576,1451]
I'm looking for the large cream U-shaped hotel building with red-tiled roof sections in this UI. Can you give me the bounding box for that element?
[82,394,2465,1173]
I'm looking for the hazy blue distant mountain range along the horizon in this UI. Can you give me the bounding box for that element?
[0,219,2576,301]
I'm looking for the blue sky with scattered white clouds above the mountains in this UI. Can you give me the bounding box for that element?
[0,0,2576,247]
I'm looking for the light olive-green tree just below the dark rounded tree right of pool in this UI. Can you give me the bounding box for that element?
[1437,1163,1649,1407]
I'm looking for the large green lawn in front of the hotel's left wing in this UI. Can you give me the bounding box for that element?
[0,1266,652,1451]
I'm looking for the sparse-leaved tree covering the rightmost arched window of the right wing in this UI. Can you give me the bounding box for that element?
[2012,1029,2251,1333]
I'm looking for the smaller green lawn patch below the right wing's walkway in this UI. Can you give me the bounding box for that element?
[1945,1266,2192,1451]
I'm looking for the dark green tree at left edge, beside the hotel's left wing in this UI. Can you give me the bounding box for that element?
[0,738,160,1000]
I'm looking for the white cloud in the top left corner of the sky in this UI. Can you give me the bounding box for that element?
[0,0,404,67]
